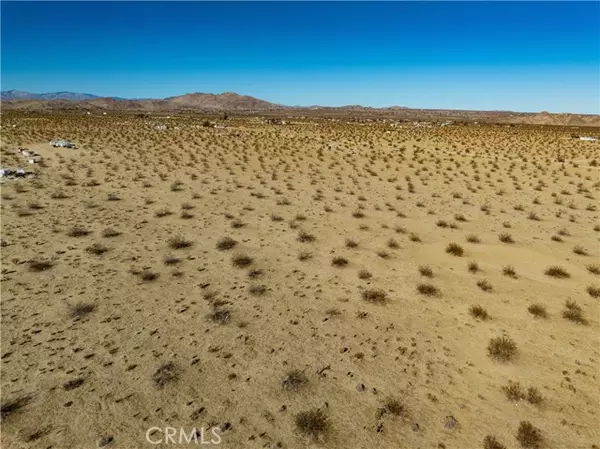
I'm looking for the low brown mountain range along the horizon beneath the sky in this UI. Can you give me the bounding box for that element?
[1,90,600,127]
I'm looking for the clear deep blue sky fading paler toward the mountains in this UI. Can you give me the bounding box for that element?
[1,1,600,114]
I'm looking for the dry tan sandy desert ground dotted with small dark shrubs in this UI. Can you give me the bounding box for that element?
[1,116,600,449]
